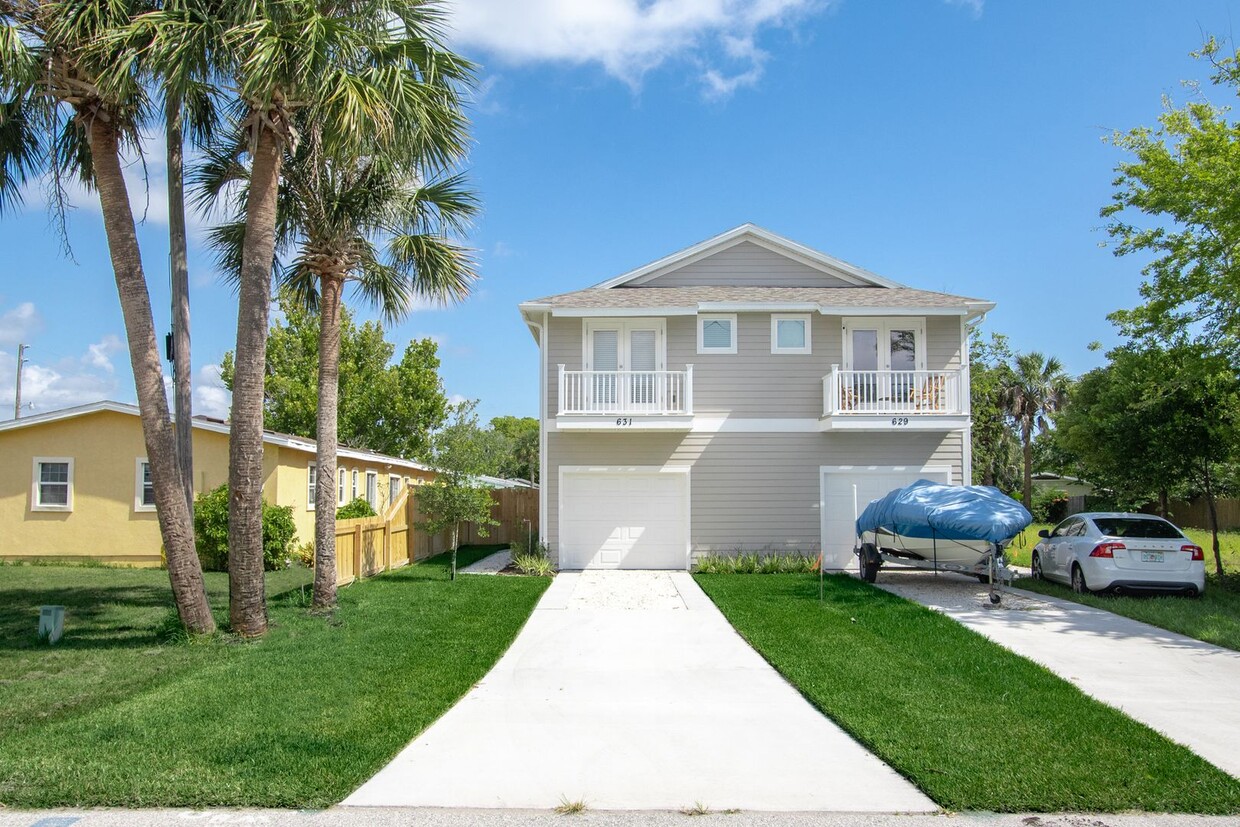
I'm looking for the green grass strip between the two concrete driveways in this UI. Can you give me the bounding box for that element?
[696,574,1240,813]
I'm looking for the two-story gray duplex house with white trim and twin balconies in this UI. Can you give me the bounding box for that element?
[521,224,994,569]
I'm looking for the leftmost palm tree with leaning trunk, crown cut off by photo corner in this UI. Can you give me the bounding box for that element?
[0,0,215,632]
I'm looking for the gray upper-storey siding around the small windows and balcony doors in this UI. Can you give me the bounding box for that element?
[547,312,961,419]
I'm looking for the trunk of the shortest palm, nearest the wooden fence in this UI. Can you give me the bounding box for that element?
[314,275,345,609]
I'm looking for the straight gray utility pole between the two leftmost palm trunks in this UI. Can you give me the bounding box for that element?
[165,97,193,515]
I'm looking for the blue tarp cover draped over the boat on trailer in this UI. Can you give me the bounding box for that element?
[857,480,1033,543]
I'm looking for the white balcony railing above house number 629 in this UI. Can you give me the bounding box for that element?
[822,365,965,417]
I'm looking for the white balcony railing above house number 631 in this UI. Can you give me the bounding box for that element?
[559,365,693,415]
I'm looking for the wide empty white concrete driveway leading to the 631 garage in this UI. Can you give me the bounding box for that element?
[343,572,936,812]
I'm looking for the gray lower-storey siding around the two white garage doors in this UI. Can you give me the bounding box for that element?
[543,431,962,565]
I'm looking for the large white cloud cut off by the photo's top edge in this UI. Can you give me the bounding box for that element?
[453,0,831,98]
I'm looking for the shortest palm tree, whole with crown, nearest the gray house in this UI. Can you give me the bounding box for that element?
[200,128,477,610]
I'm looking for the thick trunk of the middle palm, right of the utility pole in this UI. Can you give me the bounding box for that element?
[228,125,283,637]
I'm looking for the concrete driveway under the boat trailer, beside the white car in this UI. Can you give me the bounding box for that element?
[878,570,1240,777]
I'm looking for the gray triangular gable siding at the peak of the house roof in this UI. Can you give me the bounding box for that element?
[635,242,854,288]
